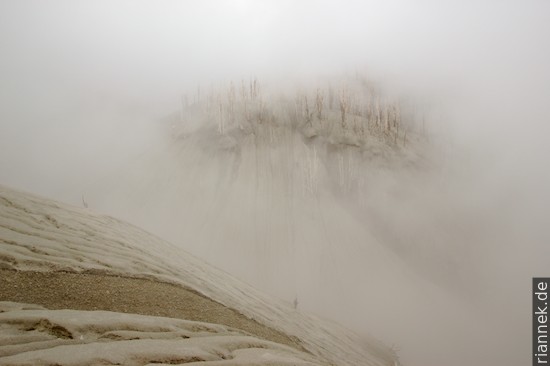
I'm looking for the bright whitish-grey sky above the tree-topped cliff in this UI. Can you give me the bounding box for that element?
[0,0,550,190]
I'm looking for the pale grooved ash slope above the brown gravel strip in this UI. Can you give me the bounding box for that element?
[0,187,397,365]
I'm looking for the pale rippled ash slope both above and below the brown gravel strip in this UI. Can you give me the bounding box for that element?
[0,187,398,366]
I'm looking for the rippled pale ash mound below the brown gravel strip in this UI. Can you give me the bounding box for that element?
[0,302,318,366]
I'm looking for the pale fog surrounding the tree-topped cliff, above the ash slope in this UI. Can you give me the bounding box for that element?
[0,0,550,365]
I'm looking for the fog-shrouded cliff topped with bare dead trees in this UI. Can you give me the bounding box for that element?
[82,74,528,363]
